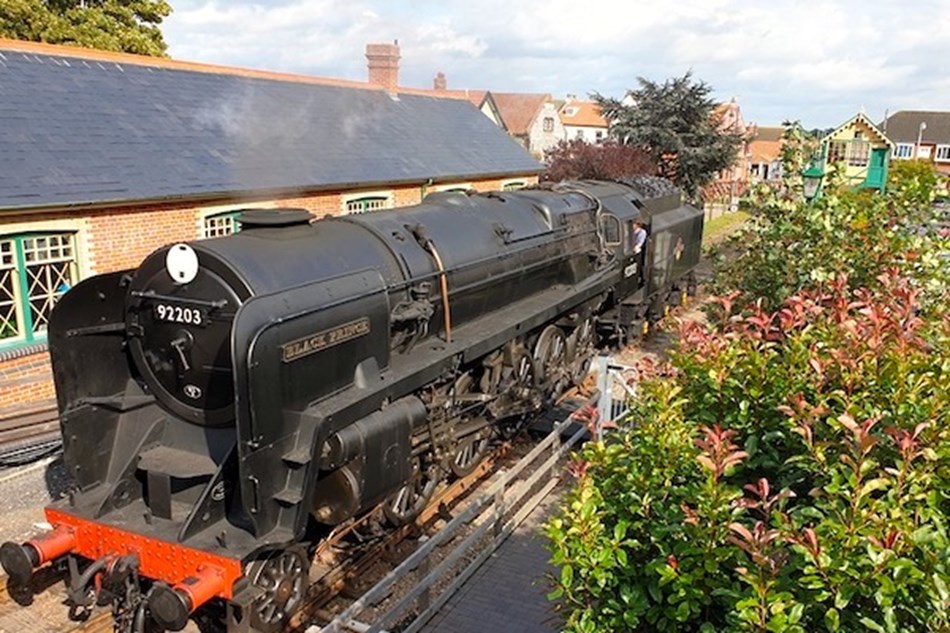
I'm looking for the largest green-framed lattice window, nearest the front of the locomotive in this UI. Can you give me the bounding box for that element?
[0,233,78,346]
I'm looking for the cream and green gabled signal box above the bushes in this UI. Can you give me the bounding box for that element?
[815,112,894,191]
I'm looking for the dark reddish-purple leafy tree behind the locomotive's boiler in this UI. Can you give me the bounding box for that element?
[542,139,657,182]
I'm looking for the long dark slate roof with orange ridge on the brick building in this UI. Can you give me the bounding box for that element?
[0,40,542,209]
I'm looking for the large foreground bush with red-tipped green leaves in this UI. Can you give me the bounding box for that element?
[548,271,950,632]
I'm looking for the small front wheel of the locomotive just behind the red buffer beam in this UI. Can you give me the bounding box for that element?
[247,547,310,633]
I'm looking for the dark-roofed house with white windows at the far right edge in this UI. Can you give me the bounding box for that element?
[880,110,950,175]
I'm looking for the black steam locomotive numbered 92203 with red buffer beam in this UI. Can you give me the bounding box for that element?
[0,178,703,631]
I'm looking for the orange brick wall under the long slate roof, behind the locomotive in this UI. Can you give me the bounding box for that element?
[0,177,537,417]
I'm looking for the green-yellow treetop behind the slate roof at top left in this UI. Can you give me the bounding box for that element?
[0,0,172,57]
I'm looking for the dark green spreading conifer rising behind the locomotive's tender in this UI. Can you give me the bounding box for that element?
[594,71,741,197]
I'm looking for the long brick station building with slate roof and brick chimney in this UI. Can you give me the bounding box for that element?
[0,40,543,419]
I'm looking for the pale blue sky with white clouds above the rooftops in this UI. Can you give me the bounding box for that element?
[162,0,950,128]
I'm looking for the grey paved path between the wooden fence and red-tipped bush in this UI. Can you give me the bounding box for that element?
[422,491,561,633]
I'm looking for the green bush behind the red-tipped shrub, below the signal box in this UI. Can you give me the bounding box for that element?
[713,133,947,310]
